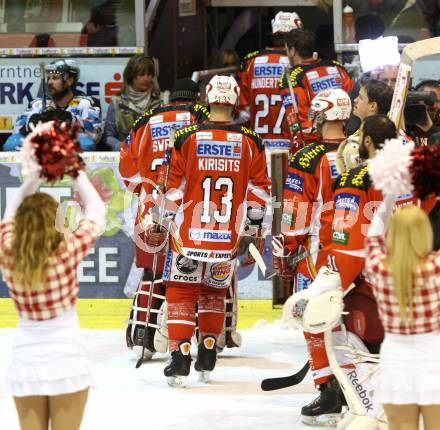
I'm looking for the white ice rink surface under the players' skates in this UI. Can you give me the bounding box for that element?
[0,321,322,430]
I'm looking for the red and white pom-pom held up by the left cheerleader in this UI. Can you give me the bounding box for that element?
[31,121,85,182]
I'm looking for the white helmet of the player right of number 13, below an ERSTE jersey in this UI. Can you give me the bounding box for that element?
[309,88,351,121]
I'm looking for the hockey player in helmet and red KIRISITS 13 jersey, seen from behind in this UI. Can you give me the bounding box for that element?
[147,76,270,385]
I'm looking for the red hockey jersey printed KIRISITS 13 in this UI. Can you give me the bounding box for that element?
[167,123,270,262]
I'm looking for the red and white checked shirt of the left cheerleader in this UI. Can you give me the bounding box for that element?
[0,218,99,321]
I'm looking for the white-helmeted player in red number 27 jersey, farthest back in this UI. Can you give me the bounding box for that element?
[239,12,302,151]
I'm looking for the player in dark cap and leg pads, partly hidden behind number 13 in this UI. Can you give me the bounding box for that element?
[119,79,209,358]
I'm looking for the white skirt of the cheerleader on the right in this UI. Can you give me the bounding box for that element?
[375,333,440,405]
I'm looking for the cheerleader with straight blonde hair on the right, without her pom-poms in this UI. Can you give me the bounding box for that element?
[366,196,440,430]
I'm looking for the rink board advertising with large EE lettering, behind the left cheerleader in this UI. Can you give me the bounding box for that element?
[0,152,272,299]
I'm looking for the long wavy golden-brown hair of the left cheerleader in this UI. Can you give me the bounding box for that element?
[12,193,64,291]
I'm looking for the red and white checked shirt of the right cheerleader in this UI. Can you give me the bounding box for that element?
[365,236,440,334]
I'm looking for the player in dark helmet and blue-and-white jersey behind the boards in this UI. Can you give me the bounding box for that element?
[3,59,102,151]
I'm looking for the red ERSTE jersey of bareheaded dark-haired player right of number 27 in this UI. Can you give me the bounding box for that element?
[279,60,353,148]
